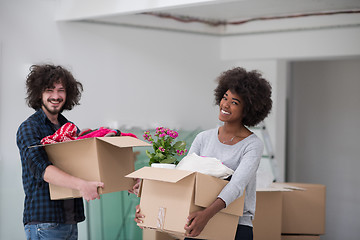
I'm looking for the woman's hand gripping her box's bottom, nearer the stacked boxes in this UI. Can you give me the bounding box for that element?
[184,210,211,237]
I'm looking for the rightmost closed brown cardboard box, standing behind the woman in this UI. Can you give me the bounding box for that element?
[282,183,326,235]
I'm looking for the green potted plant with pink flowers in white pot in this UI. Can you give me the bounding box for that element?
[143,127,187,168]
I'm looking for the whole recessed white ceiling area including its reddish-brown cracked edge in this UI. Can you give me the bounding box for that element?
[60,0,360,35]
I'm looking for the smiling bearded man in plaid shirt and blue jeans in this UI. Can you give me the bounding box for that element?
[16,64,104,239]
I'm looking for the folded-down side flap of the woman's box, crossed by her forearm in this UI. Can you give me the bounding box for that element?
[195,173,245,216]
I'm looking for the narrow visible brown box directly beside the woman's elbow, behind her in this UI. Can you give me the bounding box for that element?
[253,189,284,240]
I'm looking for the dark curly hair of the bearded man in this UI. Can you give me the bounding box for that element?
[26,64,83,112]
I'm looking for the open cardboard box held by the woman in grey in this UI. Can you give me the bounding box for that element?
[127,167,244,240]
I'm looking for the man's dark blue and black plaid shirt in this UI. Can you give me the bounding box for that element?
[16,109,85,225]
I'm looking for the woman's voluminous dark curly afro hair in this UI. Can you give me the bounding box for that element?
[214,67,272,127]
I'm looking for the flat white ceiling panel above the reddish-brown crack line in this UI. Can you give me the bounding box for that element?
[140,0,360,21]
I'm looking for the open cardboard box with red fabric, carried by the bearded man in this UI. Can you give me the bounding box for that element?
[44,136,150,200]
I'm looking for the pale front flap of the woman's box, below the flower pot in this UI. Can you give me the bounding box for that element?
[125,167,194,183]
